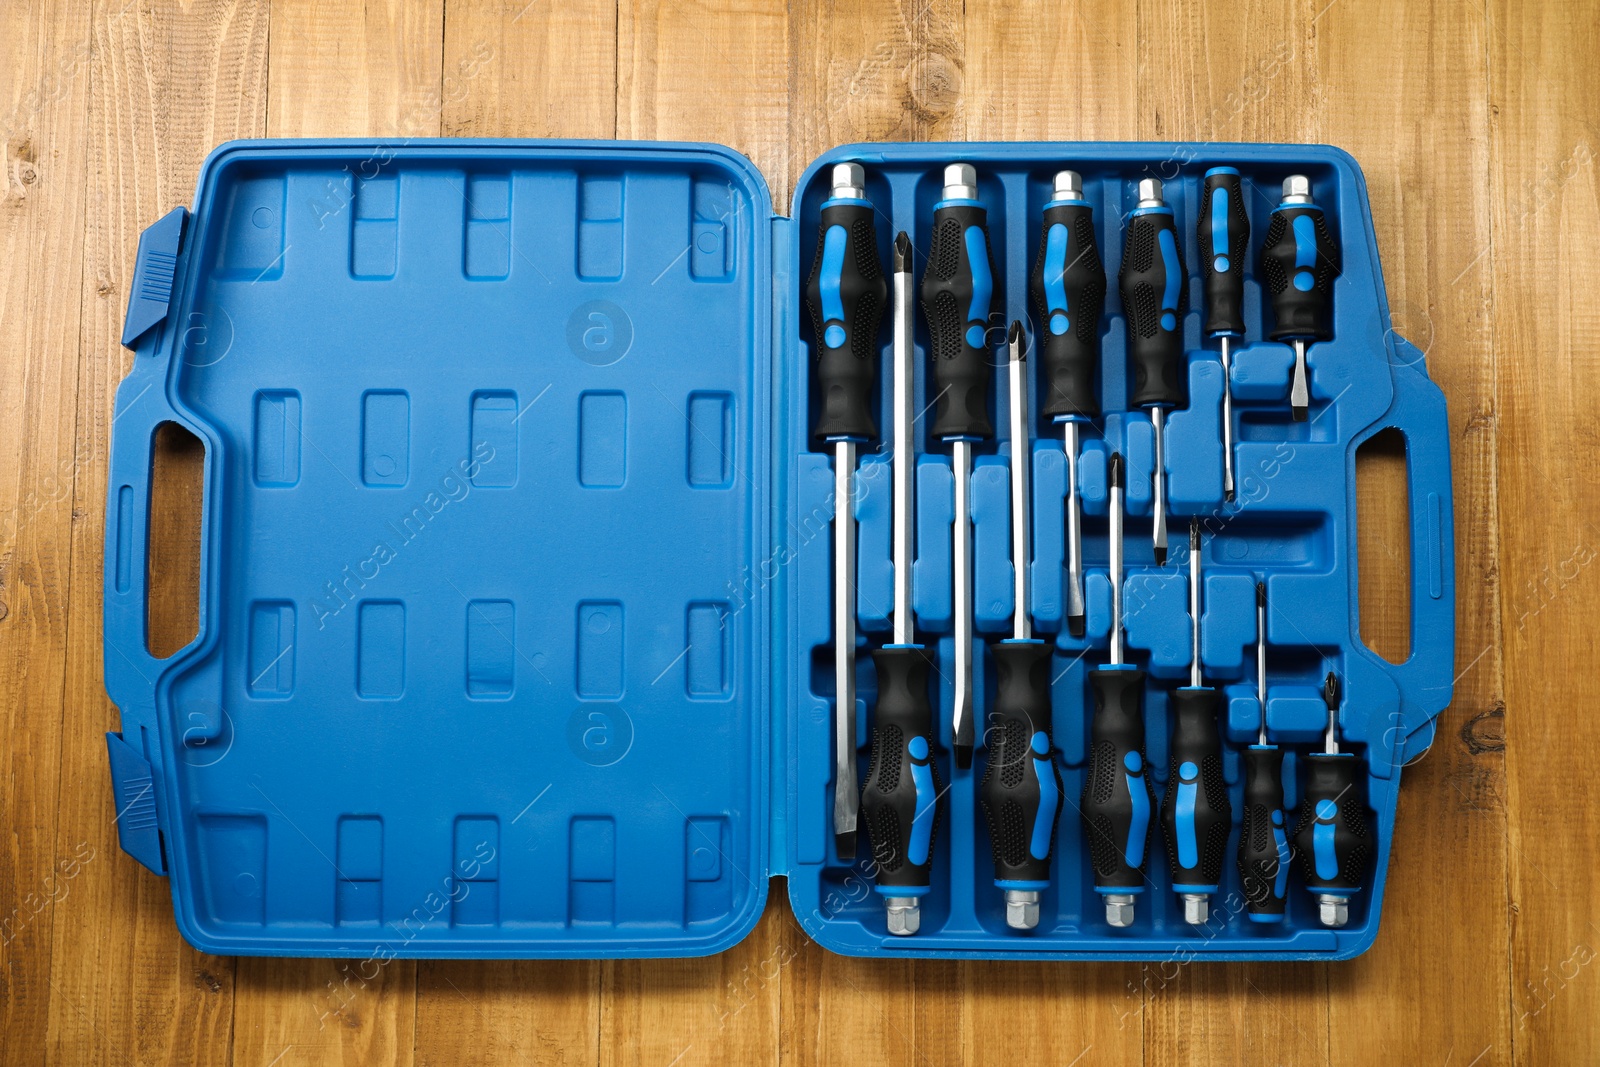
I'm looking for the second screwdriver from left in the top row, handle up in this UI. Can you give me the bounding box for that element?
[922,163,995,769]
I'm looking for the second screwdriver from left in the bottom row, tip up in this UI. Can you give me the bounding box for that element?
[978,322,1061,929]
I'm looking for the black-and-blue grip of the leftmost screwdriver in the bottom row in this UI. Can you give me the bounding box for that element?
[861,645,942,897]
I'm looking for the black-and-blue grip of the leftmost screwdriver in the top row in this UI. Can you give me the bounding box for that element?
[805,198,888,440]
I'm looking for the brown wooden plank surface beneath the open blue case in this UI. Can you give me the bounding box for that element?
[0,0,1600,1067]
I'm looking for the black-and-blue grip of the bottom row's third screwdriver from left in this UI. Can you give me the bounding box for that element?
[1078,664,1155,893]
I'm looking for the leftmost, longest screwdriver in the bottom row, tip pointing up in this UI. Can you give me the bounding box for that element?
[861,232,941,936]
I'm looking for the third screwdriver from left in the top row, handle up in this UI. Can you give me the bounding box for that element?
[1029,171,1106,637]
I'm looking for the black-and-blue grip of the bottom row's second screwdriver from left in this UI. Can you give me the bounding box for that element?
[978,640,1061,889]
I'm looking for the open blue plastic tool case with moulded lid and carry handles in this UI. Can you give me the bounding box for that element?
[104,141,1454,958]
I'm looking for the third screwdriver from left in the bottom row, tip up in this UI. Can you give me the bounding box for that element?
[1078,453,1155,926]
